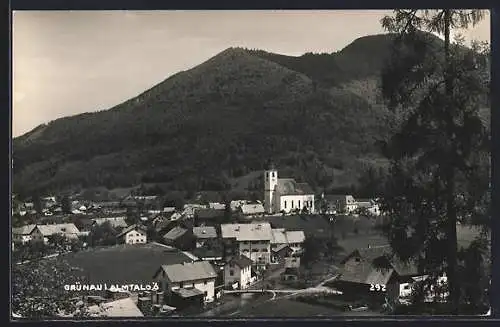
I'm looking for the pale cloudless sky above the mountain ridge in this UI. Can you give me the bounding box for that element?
[12,10,490,137]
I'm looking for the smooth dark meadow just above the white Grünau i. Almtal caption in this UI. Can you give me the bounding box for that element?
[56,243,191,284]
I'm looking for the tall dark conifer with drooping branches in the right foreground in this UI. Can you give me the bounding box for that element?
[382,9,489,314]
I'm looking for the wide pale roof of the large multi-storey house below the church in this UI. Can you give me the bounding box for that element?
[221,223,273,241]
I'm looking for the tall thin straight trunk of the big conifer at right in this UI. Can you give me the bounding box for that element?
[444,9,460,314]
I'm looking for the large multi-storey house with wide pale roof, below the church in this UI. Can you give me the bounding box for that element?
[221,223,273,265]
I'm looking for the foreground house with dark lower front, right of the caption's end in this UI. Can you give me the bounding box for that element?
[154,261,217,307]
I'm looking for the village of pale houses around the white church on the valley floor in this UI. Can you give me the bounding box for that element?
[12,167,466,317]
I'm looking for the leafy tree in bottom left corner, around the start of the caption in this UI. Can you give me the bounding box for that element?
[11,259,86,319]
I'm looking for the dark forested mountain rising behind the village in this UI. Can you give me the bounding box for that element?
[13,35,488,199]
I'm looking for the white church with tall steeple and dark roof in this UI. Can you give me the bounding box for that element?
[264,168,315,214]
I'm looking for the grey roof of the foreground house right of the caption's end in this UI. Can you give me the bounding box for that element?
[161,261,217,283]
